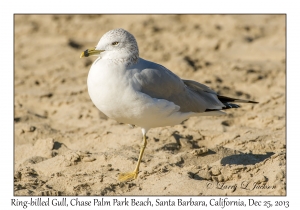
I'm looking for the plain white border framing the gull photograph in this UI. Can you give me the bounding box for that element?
[0,0,300,209]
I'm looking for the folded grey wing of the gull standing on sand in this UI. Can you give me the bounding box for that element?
[134,60,224,112]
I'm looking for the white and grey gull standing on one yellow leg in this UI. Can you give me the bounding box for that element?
[80,29,257,181]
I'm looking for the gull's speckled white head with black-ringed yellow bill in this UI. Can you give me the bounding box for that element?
[80,28,139,65]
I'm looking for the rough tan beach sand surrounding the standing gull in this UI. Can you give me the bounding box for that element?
[14,15,286,195]
